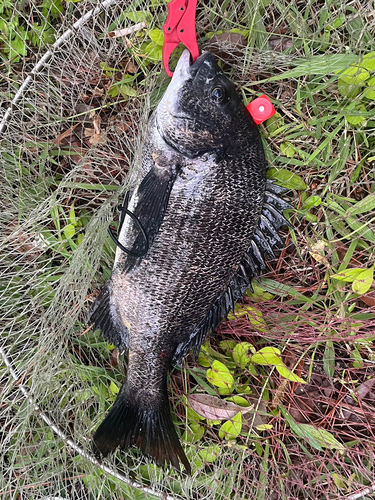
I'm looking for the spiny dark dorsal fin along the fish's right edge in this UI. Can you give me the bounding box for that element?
[173,181,293,363]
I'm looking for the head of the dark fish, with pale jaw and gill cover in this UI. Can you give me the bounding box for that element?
[156,50,250,158]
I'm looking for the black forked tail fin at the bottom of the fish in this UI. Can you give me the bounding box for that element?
[93,382,191,474]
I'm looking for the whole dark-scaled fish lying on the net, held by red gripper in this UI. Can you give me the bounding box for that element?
[91,51,290,473]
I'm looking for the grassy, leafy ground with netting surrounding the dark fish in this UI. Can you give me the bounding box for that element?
[0,0,375,500]
